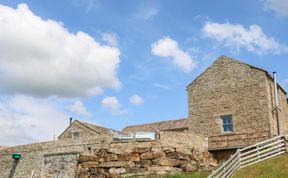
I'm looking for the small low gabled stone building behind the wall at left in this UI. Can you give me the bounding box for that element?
[58,120,113,140]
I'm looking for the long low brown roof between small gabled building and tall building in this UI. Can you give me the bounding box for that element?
[122,118,189,133]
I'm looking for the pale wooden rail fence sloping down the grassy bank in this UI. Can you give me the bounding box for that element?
[208,136,286,178]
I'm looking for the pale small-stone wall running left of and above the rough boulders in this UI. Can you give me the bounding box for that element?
[0,132,207,178]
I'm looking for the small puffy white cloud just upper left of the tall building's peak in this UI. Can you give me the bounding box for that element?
[151,37,196,73]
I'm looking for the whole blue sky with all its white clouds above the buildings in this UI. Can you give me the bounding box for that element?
[0,0,288,146]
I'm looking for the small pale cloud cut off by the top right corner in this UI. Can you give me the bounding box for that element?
[263,0,288,17]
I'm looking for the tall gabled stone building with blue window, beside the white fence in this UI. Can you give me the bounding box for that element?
[187,56,288,160]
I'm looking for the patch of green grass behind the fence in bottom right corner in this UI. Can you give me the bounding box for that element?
[233,154,288,178]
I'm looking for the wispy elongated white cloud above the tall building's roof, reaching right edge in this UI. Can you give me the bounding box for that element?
[202,22,288,55]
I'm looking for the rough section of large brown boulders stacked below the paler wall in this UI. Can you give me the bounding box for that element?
[76,142,217,178]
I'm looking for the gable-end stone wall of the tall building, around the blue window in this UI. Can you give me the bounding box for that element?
[187,57,271,146]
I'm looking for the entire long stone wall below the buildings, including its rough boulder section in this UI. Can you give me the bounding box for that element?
[0,132,212,178]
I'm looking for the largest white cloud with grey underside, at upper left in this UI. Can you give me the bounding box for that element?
[0,4,121,97]
